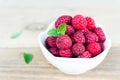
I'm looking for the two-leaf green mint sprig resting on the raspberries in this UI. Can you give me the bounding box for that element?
[47,23,66,36]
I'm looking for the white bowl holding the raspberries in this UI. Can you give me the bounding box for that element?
[38,21,111,74]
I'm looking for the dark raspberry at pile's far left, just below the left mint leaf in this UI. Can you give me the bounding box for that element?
[46,36,57,47]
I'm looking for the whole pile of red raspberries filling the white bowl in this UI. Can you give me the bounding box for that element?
[45,15,106,58]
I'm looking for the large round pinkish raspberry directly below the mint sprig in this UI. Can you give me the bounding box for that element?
[56,35,72,49]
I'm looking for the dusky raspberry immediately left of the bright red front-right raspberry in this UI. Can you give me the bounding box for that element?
[72,43,85,56]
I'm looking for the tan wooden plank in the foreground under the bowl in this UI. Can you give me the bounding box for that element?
[0,47,120,80]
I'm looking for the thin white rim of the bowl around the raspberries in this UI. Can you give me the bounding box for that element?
[38,21,112,60]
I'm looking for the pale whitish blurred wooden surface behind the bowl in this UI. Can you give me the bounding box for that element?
[0,0,120,48]
